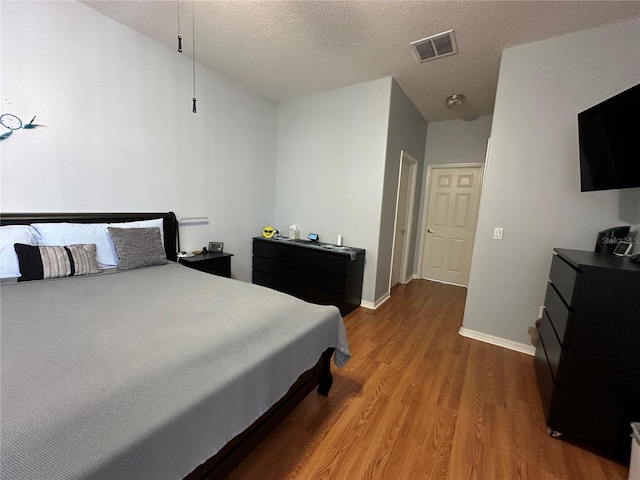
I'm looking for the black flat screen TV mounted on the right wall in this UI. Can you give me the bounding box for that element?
[578,84,640,192]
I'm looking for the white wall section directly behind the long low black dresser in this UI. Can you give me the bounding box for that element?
[275,77,391,302]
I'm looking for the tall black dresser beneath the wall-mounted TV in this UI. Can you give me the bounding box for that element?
[534,249,640,464]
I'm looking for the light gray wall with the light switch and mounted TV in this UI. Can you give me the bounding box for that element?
[462,20,640,344]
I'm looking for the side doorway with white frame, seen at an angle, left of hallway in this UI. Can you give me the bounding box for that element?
[389,151,418,290]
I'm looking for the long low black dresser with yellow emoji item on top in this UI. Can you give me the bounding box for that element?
[253,237,365,316]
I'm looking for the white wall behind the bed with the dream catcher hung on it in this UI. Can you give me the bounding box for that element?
[0,1,276,280]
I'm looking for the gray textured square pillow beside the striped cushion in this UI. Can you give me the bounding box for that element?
[107,227,168,270]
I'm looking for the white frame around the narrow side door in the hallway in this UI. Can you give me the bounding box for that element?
[387,150,418,292]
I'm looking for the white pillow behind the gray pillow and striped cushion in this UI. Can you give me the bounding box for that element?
[32,222,118,268]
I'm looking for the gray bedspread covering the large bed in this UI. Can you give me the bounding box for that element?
[0,264,350,480]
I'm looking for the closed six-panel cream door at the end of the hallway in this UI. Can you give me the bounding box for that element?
[421,166,482,286]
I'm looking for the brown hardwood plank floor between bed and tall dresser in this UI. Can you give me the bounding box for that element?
[229,280,628,480]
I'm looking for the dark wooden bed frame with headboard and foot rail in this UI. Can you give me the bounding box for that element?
[0,212,334,480]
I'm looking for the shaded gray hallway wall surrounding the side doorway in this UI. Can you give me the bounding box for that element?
[375,80,427,300]
